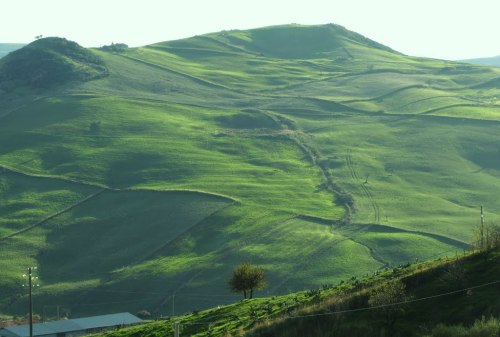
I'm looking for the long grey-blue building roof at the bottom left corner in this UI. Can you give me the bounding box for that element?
[0,312,143,337]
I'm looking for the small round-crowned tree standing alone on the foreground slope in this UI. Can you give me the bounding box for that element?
[229,262,266,298]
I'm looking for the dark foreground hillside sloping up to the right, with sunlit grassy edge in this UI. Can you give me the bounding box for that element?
[89,245,500,337]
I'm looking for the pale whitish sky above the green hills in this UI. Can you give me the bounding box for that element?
[0,0,500,60]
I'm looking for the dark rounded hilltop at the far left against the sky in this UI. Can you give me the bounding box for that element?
[0,37,108,90]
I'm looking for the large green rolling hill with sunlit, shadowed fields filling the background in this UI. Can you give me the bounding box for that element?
[0,24,500,315]
